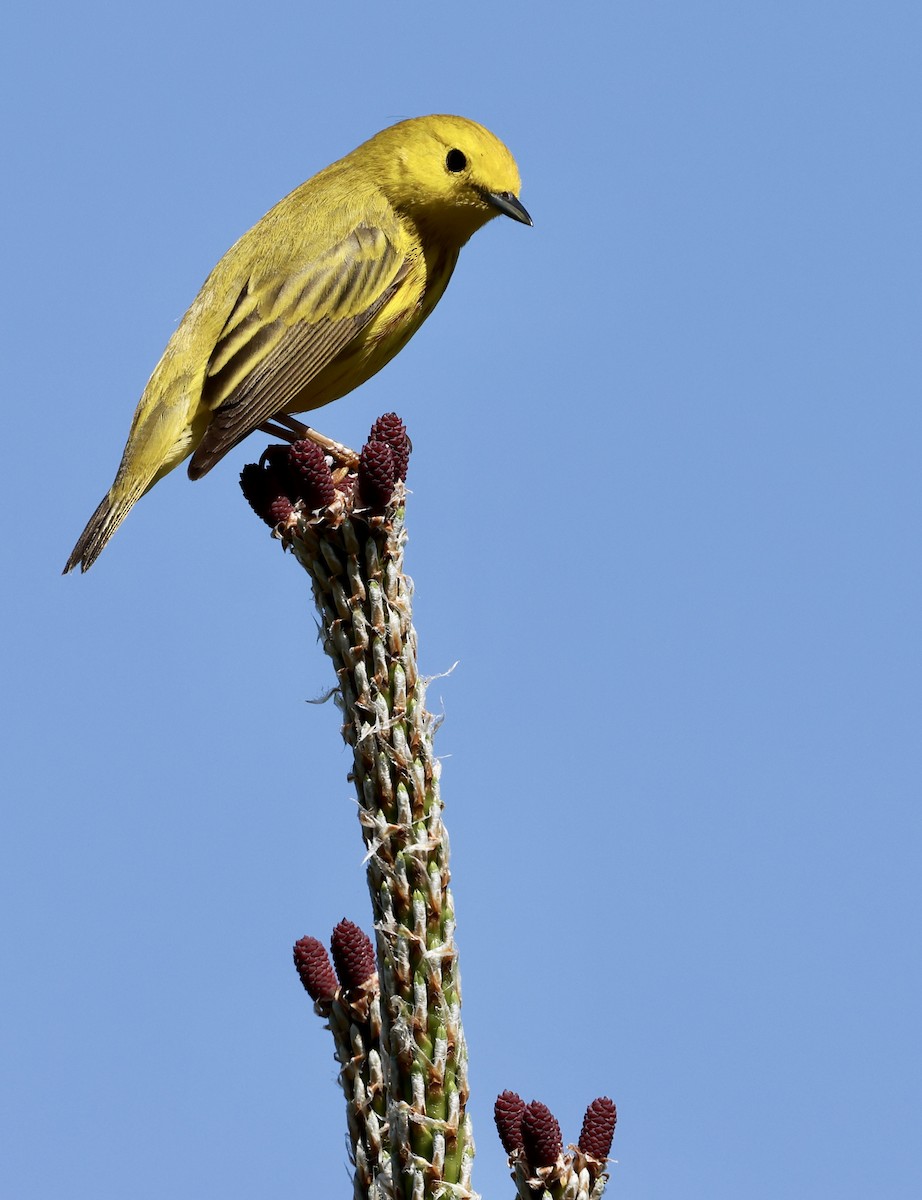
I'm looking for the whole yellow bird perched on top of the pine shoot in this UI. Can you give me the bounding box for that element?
[64,116,532,574]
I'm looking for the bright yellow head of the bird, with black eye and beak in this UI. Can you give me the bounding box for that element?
[363,115,532,246]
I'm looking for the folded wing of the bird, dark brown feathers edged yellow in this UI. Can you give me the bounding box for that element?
[188,224,407,479]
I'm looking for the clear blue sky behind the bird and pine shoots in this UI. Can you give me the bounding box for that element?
[0,0,922,1200]
